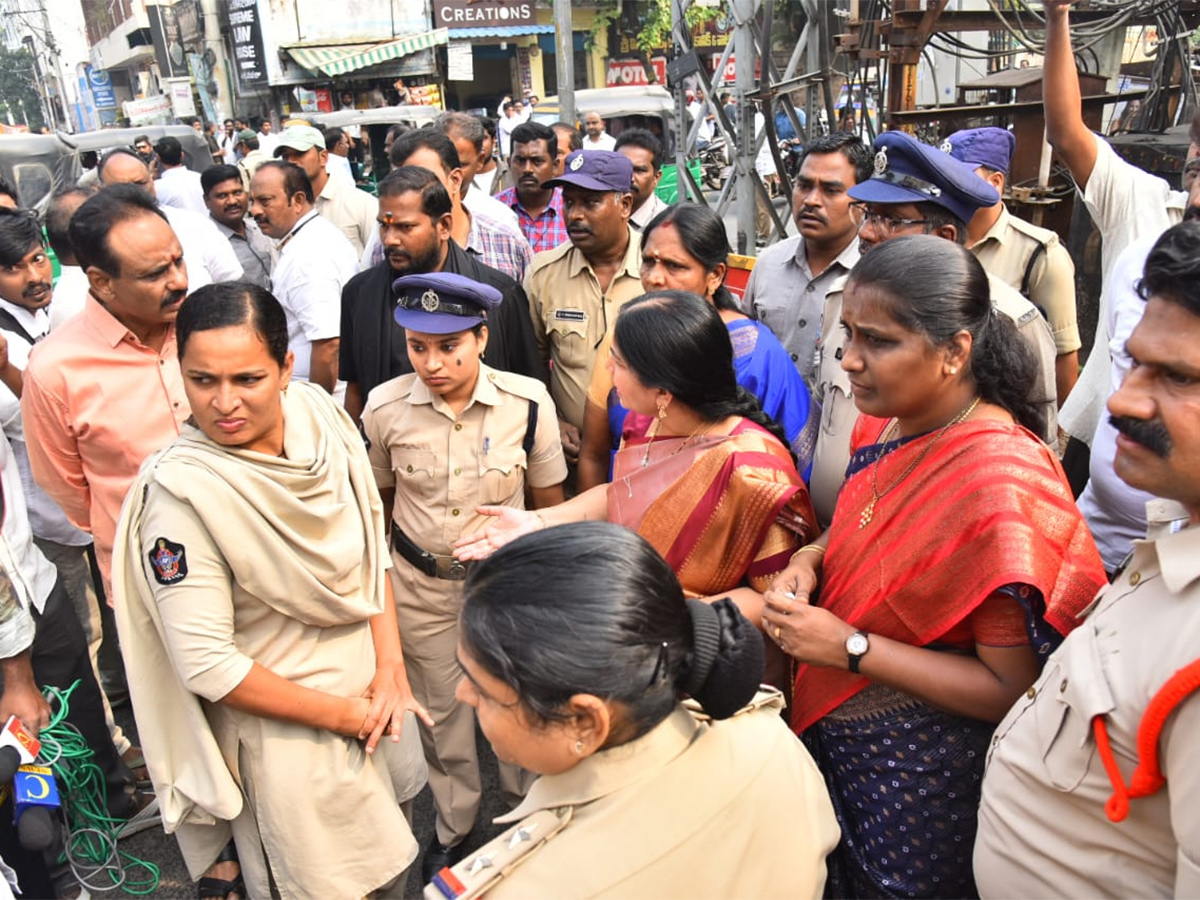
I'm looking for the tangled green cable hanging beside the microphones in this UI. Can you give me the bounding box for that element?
[37,682,160,896]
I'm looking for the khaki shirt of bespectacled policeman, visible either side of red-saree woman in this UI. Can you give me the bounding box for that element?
[809,274,1058,528]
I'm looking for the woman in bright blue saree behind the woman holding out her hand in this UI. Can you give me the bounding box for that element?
[578,203,821,491]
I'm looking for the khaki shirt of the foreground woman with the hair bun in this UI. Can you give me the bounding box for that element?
[425,690,840,900]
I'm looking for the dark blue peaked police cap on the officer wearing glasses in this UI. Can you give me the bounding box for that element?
[846,131,1000,222]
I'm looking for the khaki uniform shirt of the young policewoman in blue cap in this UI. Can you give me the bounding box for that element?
[362,365,566,554]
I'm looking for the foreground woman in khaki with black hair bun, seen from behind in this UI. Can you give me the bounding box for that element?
[425,522,838,900]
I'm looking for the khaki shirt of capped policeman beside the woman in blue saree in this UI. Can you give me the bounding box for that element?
[524,229,646,428]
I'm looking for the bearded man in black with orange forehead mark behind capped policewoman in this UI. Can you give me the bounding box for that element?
[338,166,548,421]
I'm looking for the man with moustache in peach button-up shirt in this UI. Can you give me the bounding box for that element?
[20,185,190,602]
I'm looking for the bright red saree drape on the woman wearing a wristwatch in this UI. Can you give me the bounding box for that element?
[792,416,1105,732]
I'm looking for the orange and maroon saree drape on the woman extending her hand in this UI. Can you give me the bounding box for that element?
[608,420,816,596]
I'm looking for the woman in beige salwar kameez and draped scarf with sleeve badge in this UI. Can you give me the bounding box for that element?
[114,283,426,898]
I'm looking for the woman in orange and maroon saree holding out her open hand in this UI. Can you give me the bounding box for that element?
[456,290,816,623]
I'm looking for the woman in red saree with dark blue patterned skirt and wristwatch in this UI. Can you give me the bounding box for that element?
[763,236,1104,896]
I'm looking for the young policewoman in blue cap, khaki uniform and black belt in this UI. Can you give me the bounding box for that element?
[362,272,566,881]
